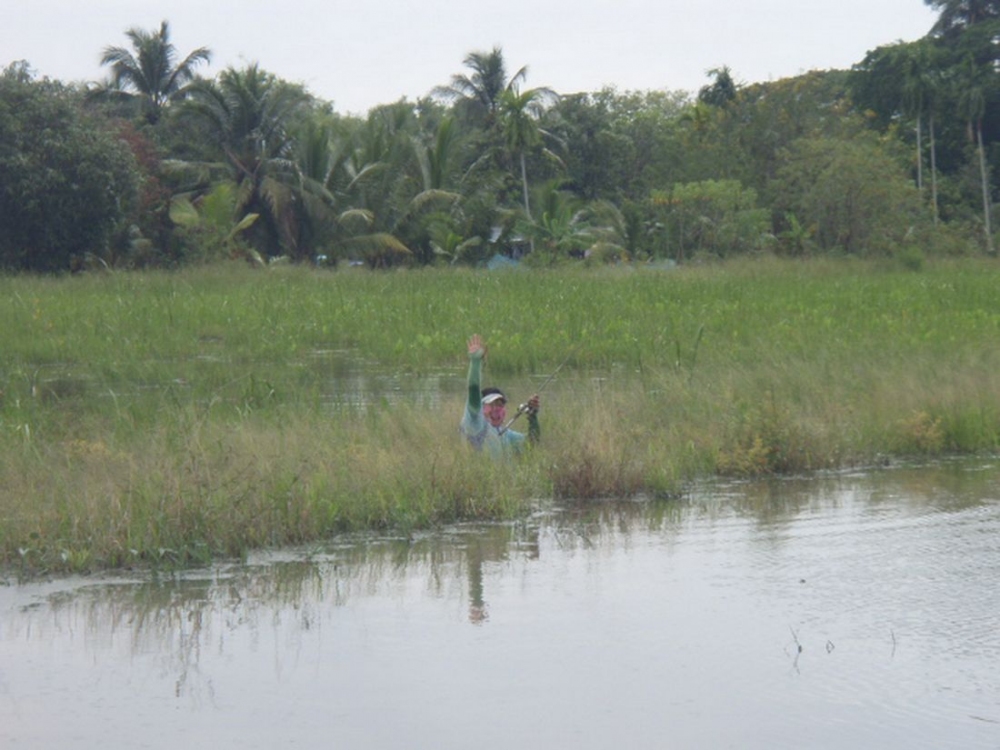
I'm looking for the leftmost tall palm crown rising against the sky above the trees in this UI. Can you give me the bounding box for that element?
[101,21,212,123]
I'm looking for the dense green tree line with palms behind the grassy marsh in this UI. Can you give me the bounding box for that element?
[0,0,1000,272]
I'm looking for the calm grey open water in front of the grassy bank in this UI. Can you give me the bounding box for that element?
[0,462,1000,750]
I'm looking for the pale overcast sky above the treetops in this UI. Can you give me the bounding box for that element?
[0,0,936,114]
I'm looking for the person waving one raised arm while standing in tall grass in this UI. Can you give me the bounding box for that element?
[461,333,541,457]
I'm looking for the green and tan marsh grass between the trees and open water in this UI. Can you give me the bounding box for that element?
[0,261,1000,571]
